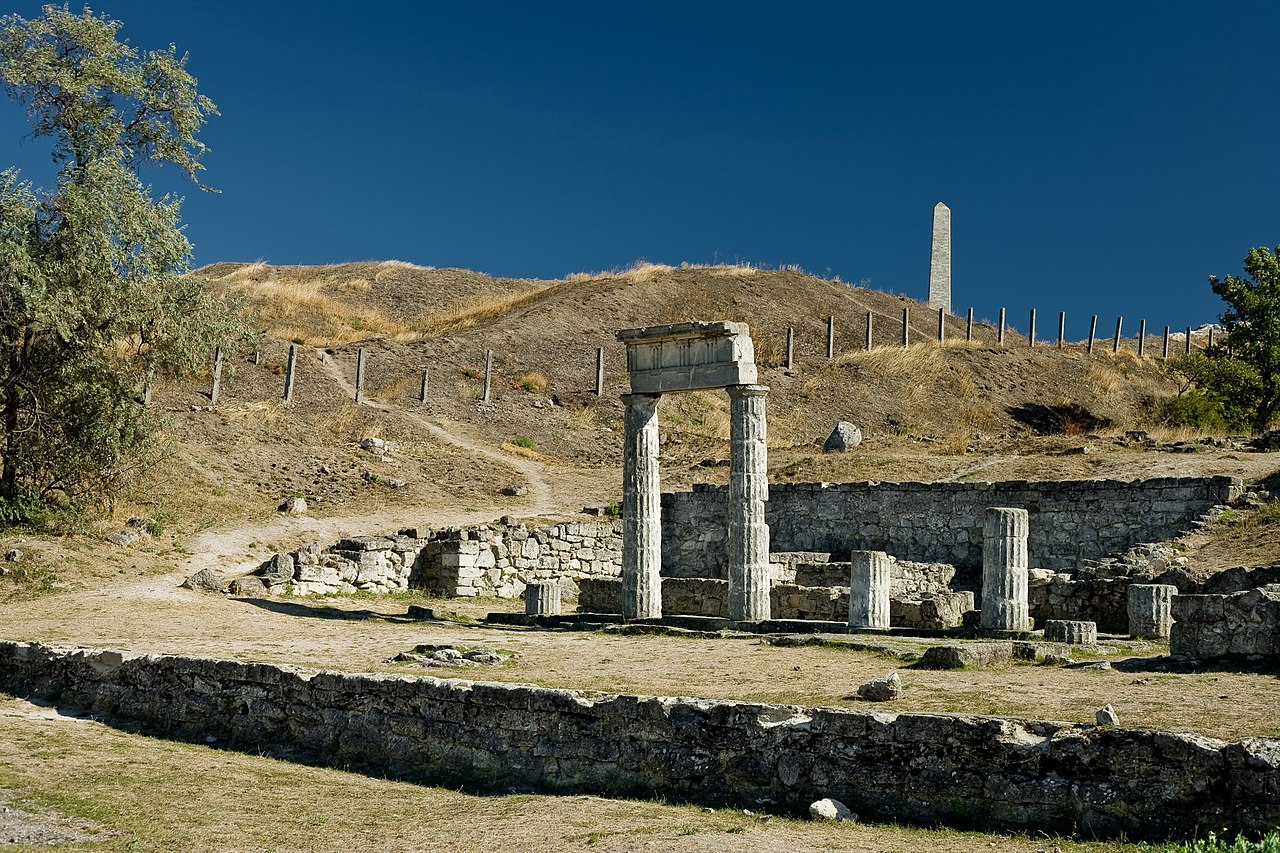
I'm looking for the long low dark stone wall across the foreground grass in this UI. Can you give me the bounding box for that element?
[0,643,1280,839]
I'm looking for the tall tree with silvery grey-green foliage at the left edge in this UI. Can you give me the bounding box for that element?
[0,6,248,523]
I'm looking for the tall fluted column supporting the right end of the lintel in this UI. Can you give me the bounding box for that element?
[726,386,769,622]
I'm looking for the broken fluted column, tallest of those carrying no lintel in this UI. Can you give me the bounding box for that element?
[980,506,1030,631]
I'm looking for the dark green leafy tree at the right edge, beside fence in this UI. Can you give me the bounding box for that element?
[1189,247,1280,433]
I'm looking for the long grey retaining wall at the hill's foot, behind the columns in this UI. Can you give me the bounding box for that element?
[662,476,1242,578]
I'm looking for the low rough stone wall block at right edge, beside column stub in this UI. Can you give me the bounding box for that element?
[1169,584,1280,660]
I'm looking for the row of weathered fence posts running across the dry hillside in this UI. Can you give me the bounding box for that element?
[209,307,1213,406]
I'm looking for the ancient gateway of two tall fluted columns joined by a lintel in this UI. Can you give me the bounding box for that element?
[617,321,769,621]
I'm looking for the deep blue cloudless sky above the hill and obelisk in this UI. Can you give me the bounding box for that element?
[0,0,1280,337]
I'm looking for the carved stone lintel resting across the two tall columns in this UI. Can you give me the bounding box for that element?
[617,321,756,393]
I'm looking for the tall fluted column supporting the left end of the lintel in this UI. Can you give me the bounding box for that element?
[622,394,662,619]
